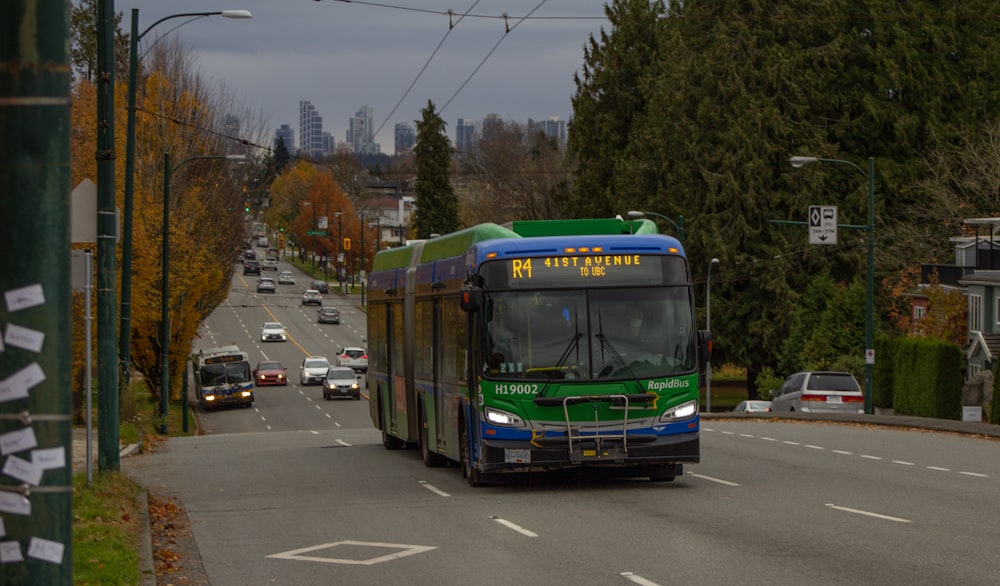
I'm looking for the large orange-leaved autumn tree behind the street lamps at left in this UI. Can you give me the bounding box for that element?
[120,43,266,398]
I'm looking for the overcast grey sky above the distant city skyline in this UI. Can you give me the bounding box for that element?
[115,0,608,154]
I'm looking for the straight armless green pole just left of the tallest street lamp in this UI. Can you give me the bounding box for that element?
[97,0,120,470]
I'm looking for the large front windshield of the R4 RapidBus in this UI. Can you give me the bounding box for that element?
[481,286,696,380]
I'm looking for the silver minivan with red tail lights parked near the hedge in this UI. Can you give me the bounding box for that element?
[771,371,865,413]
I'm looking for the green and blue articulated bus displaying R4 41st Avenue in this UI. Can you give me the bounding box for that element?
[367,219,711,486]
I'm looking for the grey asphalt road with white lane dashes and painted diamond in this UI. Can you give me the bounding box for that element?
[128,260,1000,586]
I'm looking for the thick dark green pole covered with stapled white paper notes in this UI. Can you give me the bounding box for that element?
[0,0,73,585]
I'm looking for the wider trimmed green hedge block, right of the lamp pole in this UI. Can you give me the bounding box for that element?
[892,338,962,420]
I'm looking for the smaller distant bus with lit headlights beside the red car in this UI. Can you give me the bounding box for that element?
[191,346,253,409]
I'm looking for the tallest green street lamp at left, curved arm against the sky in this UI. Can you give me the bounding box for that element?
[118,8,253,402]
